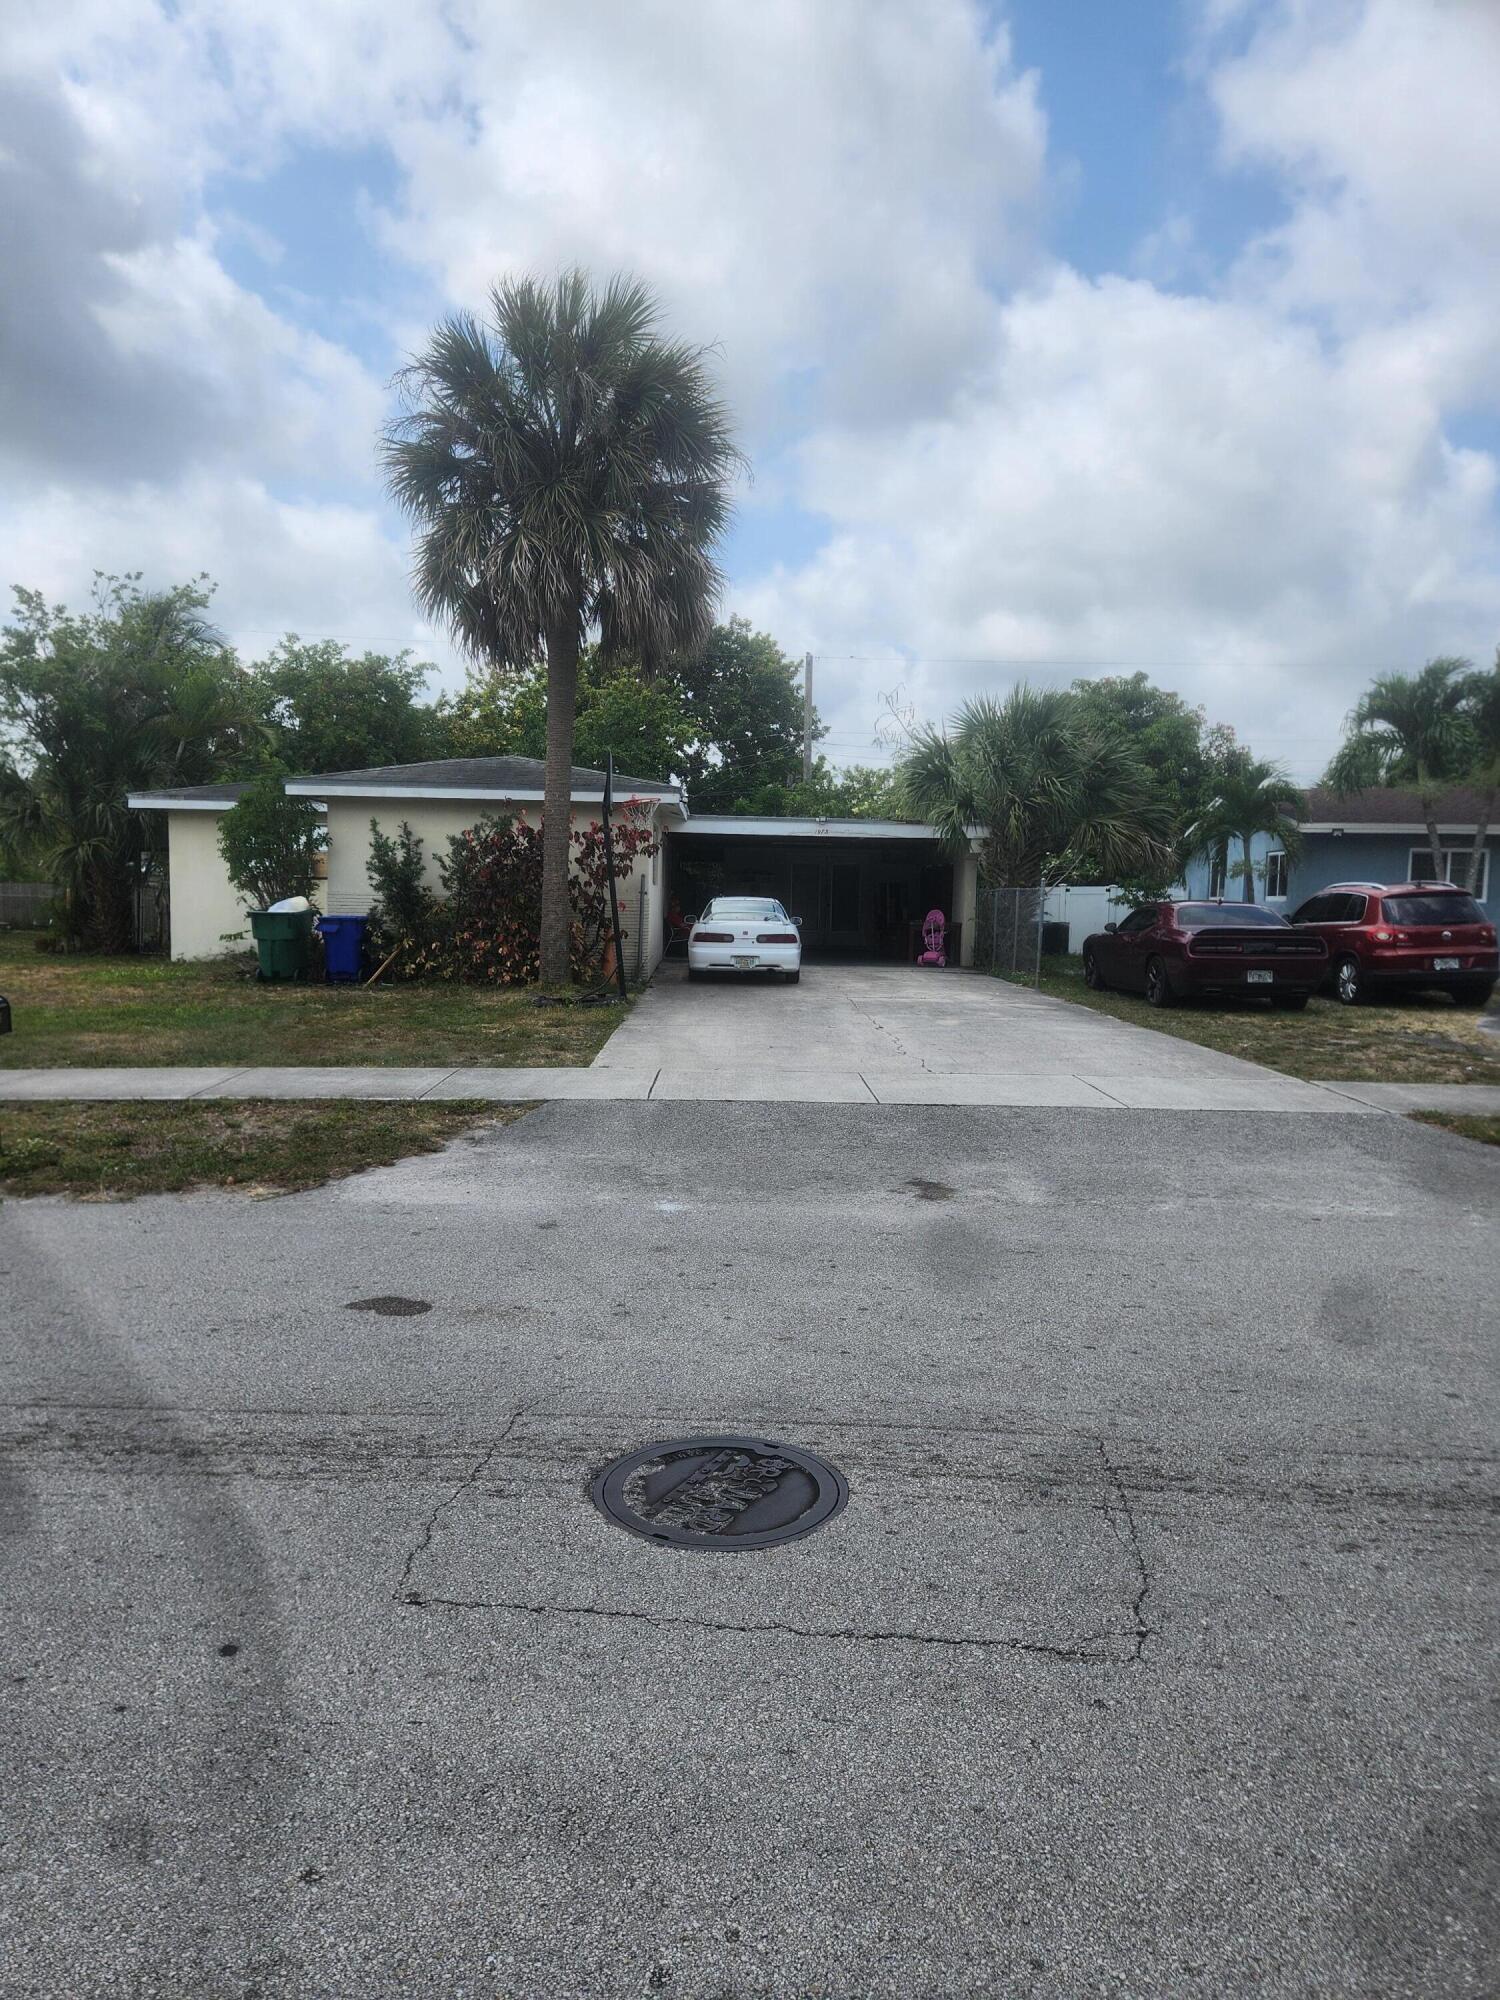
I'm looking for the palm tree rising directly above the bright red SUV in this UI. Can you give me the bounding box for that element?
[1326,658,1478,888]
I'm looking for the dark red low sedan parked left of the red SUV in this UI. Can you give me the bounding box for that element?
[1084,902,1328,1008]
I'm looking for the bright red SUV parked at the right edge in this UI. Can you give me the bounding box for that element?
[1292,882,1500,1006]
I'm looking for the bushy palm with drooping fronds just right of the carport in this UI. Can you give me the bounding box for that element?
[896,684,1172,888]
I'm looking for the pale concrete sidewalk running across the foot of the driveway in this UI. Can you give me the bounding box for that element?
[0,1062,1500,1116]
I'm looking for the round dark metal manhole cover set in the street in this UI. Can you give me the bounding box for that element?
[590,1438,848,1548]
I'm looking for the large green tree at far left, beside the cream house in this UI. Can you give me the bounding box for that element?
[0,572,264,952]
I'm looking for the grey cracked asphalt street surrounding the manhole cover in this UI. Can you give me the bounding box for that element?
[0,1102,1500,2000]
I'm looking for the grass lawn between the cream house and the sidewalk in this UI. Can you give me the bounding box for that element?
[0,930,626,1070]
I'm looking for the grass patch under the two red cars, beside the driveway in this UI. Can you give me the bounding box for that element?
[1022,958,1500,1084]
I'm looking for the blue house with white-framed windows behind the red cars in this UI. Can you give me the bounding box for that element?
[1186,786,1500,924]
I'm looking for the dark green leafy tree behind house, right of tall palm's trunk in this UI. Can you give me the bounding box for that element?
[674,618,828,812]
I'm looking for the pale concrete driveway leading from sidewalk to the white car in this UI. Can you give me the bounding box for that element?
[592,964,1366,1112]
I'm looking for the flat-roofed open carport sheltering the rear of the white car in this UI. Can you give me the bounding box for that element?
[666,816,976,964]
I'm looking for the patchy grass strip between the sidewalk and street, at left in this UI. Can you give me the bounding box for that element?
[0,1100,530,1200]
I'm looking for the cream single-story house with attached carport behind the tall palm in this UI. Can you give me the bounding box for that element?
[130,756,978,976]
